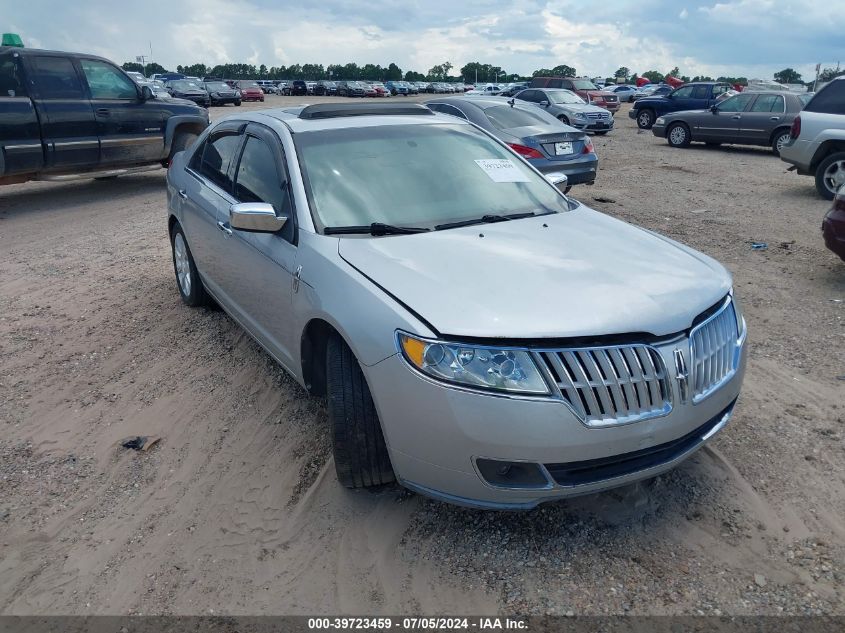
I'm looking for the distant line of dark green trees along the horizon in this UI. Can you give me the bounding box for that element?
[123,62,845,85]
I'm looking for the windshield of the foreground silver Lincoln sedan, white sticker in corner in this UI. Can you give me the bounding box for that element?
[294,123,569,228]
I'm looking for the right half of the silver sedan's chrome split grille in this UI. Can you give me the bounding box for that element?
[690,299,739,402]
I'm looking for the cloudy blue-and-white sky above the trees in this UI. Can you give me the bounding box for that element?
[8,0,845,80]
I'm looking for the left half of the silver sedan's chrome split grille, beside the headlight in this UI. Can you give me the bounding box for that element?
[539,345,672,426]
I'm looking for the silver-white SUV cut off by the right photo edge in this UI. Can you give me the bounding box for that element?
[780,76,845,200]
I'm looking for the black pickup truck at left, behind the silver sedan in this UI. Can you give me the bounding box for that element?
[0,47,209,185]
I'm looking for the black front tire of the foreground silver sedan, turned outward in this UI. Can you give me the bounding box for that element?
[326,334,396,488]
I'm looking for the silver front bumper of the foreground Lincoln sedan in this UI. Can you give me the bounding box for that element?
[364,330,746,510]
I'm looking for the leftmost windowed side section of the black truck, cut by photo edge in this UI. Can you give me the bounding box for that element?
[0,53,44,177]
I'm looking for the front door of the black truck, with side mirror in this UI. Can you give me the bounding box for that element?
[79,58,165,167]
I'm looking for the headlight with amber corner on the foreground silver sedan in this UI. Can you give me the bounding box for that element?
[399,333,549,395]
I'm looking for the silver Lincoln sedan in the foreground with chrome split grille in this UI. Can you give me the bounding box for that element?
[167,103,746,509]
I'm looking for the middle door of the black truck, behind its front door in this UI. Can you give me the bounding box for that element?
[21,55,100,171]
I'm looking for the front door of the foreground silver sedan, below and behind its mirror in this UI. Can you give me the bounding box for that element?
[211,123,297,368]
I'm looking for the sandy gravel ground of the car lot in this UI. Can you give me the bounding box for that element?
[0,97,845,614]
